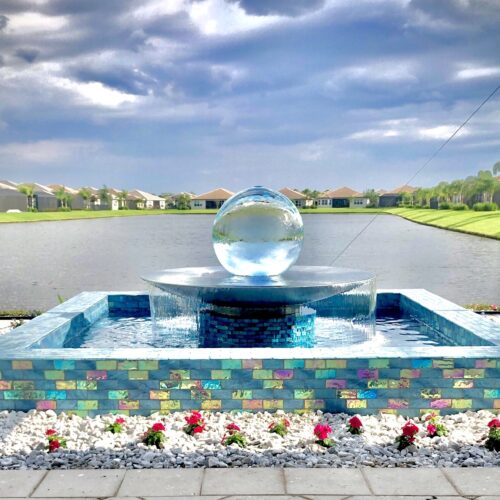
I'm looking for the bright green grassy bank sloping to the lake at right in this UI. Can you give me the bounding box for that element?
[387,208,500,240]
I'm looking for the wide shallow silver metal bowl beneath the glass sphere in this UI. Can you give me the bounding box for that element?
[142,266,375,308]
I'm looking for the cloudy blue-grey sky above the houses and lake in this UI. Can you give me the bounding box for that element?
[0,0,500,193]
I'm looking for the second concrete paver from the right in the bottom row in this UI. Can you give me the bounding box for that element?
[363,468,459,496]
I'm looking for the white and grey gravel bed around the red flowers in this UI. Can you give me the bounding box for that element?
[0,410,500,469]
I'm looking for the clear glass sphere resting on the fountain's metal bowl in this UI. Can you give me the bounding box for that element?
[212,186,304,276]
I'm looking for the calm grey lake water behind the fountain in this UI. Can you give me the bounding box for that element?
[0,214,500,309]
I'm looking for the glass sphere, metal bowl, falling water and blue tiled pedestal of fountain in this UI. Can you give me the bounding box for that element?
[143,186,376,347]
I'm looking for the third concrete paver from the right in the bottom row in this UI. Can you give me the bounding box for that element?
[285,469,370,496]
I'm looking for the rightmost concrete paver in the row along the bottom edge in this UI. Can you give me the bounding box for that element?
[444,467,500,498]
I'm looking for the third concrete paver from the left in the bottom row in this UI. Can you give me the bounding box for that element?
[117,469,204,497]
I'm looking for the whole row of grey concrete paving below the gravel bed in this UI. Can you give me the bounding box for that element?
[0,468,500,500]
